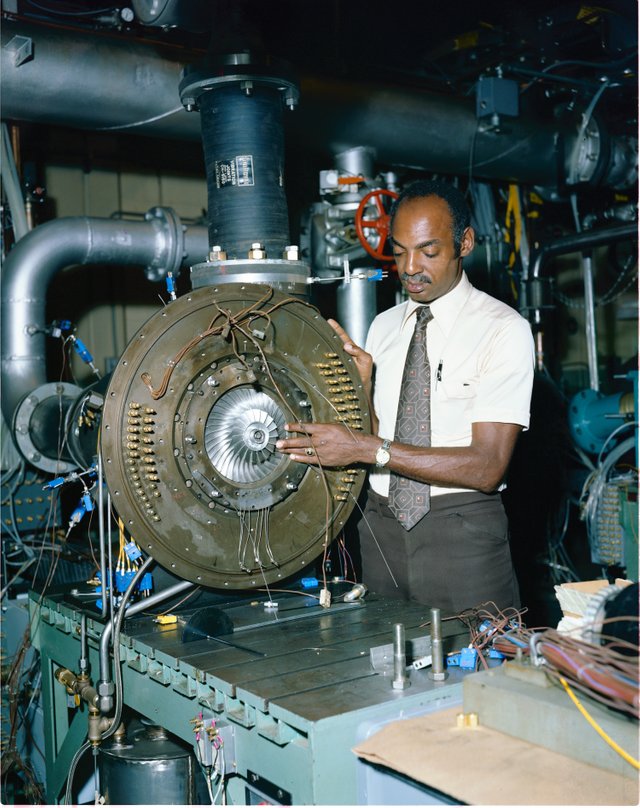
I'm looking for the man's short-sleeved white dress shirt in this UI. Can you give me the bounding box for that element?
[366,273,535,497]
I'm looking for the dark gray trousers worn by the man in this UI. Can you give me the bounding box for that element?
[358,490,520,617]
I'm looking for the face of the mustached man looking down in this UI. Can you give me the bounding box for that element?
[391,196,474,303]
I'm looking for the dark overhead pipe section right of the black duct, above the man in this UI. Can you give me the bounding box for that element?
[298,78,575,185]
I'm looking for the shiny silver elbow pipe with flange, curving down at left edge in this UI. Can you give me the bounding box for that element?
[0,208,208,424]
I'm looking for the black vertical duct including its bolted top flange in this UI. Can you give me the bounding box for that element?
[180,51,298,260]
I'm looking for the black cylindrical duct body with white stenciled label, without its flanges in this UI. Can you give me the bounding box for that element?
[199,85,289,258]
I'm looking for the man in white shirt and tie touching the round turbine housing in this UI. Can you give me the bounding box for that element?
[277,181,534,614]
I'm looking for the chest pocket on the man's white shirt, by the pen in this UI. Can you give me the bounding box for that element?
[431,379,478,446]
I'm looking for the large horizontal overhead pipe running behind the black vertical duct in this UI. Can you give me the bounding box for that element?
[0,20,637,186]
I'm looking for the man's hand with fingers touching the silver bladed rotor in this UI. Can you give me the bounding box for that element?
[276,423,380,468]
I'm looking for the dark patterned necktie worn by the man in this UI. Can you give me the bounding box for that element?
[389,306,433,530]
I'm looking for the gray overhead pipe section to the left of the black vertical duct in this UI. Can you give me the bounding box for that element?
[0,20,200,141]
